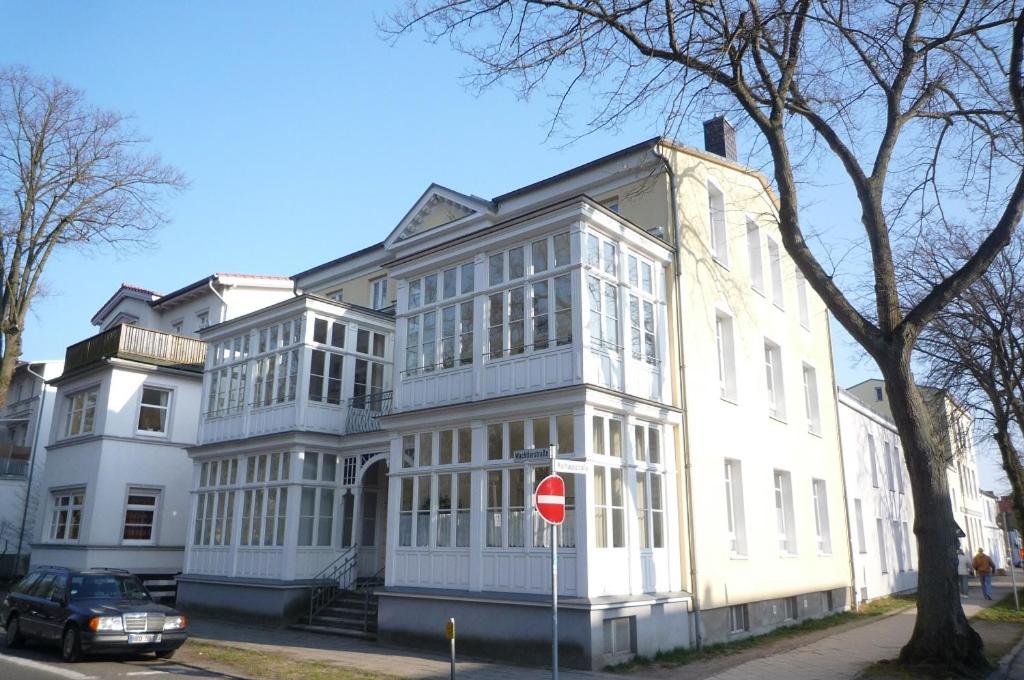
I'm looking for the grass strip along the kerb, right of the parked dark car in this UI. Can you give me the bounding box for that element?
[175,640,392,680]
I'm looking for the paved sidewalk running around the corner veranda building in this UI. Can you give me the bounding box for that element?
[184,578,1024,680]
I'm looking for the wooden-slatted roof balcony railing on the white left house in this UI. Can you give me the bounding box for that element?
[65,324,206,373]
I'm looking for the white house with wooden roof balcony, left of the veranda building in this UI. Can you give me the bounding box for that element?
[32,274,293,593]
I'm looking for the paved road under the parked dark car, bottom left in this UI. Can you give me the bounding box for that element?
[0,638,231,680]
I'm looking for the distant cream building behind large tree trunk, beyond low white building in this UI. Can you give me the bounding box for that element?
[849,379,987,555]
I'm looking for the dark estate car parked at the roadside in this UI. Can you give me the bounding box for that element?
[0,566,188,662]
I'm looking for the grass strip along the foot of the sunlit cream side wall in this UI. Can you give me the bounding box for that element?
[604,595,915,673]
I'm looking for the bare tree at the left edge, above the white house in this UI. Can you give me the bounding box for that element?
[0,68,184,405]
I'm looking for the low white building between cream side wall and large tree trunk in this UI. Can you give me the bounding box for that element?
[839,390,918,603]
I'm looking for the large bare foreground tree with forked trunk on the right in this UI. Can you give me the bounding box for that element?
[382,0,1024,669]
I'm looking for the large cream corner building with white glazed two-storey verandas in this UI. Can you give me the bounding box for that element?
[179,129,851,667]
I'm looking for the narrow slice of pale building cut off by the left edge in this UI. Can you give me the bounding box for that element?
[0,360,63,578]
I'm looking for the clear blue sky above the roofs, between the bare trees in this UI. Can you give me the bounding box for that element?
[0,0,1007,489]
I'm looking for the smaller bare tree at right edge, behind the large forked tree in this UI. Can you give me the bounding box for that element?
[900,226,1024,526]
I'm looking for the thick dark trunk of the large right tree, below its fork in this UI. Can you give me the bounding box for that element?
[879,356,987,669]
